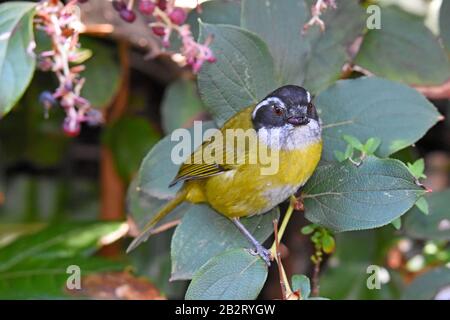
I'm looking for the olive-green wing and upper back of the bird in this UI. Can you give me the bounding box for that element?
[170,106,253,186]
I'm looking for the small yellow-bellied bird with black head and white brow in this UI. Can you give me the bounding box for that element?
[127,85,322,266]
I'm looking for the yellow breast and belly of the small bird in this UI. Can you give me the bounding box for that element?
[185,141,322,218]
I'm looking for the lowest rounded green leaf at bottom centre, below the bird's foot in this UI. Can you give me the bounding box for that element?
[186,249,267,300]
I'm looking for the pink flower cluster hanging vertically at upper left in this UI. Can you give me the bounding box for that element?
[35,0,102,136]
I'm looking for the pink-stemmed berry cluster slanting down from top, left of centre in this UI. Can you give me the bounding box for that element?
[112,0,215,73]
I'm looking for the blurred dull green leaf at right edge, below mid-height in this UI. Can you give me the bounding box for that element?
[403,189,450,241]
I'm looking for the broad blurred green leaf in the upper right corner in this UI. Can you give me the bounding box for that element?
[355,7,450,85]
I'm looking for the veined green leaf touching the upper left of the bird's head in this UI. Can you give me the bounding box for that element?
[198,24,276,126]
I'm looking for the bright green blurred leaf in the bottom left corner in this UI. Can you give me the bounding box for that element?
[0,222,124,299]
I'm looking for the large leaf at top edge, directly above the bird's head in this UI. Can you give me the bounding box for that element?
[241,0,364,93]
